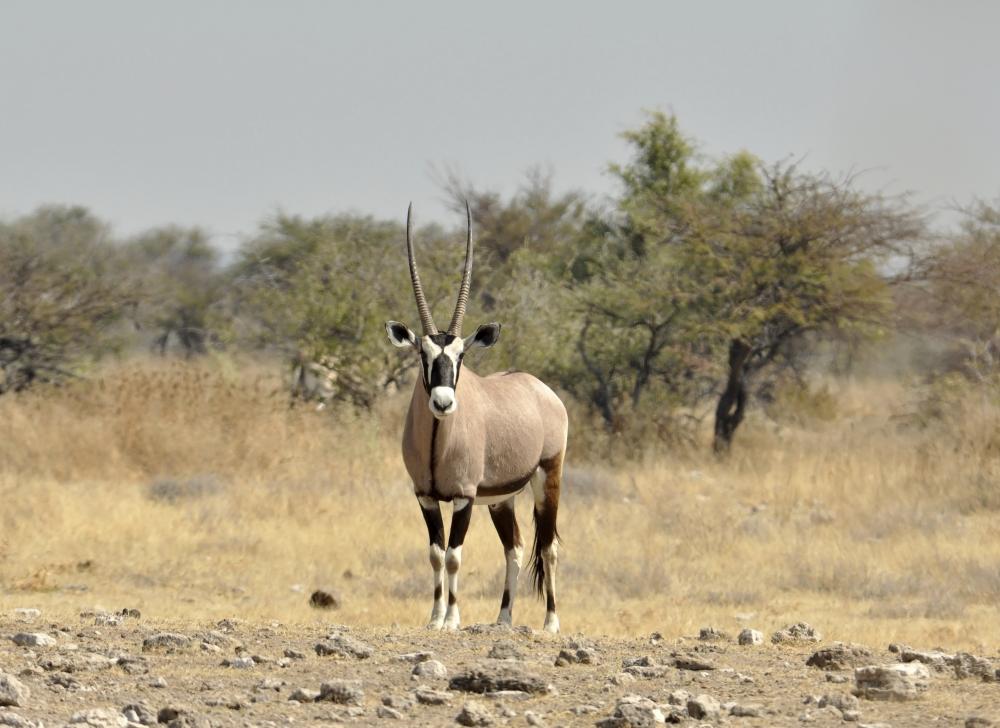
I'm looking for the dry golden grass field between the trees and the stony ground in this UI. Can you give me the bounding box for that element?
[0,361,1000,652]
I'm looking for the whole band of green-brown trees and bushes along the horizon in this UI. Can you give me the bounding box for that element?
[0,113,1000,449]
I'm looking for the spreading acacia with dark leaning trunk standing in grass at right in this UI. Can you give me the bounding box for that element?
[693,164,923,451]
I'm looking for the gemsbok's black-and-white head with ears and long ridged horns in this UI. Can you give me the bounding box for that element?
[385,202,500,419]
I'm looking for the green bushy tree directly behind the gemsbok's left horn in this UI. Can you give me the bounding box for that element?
[231,215,464,407]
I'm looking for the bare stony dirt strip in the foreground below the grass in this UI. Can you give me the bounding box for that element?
[0,614,1000,727]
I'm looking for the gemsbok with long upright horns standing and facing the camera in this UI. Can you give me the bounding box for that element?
[385,203,569,632]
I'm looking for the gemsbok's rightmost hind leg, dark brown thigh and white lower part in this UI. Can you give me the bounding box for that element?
[531,451,565,633]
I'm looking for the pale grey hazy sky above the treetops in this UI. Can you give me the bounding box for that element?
[0,0,1000,247]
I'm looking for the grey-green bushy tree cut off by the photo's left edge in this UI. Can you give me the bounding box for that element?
[0,207,138,392]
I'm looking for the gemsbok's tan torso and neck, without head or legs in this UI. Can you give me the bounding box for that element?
[403,367,569,504]
